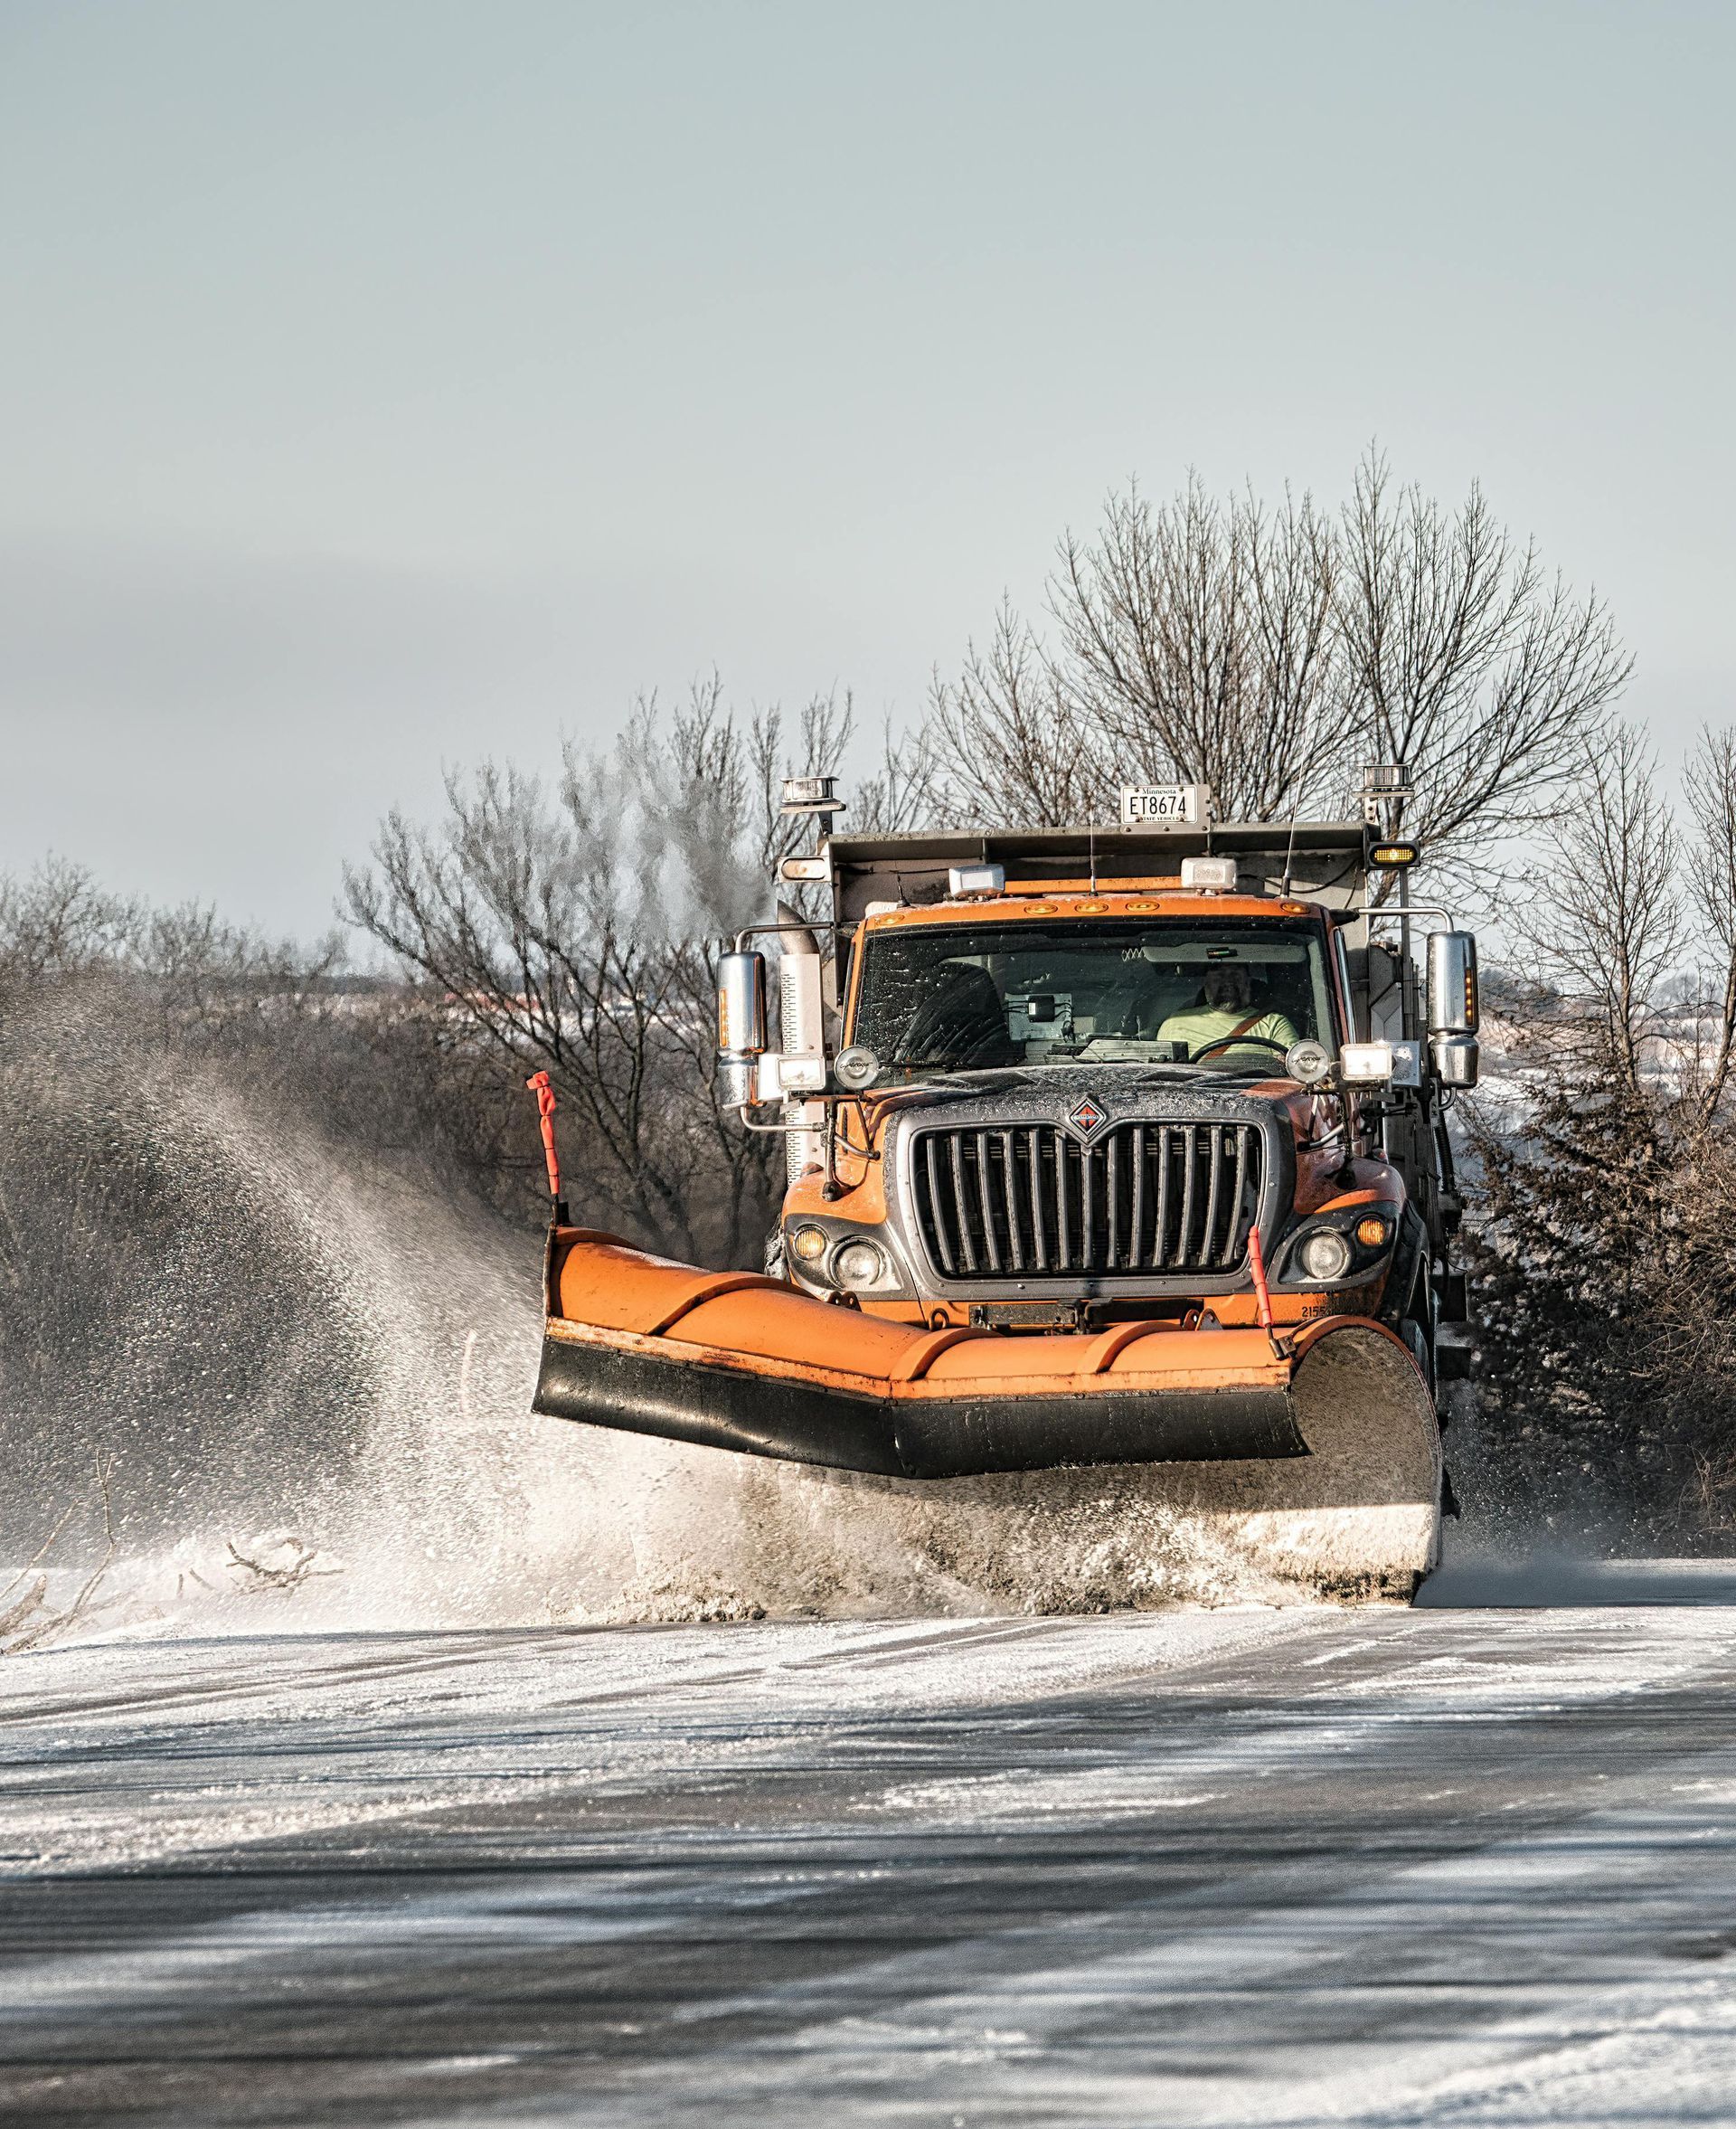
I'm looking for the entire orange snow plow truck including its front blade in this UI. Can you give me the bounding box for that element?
[534,764,1478,1594]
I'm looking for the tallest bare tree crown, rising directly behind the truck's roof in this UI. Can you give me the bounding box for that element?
[929,451,1629,877]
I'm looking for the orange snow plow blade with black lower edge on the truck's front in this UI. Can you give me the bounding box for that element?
[534,1228,1440,1582]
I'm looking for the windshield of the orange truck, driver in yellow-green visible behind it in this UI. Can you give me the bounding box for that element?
[851,918,1338,1077]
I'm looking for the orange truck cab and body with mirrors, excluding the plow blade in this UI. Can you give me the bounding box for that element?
[722,809,1477,1388]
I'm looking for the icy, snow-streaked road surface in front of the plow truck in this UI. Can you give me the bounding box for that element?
[0,1569,1736,2129]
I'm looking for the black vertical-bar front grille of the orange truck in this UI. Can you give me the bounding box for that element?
[910,1124,1261,1280]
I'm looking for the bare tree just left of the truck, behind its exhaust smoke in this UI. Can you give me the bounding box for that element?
[344,677,851,1261]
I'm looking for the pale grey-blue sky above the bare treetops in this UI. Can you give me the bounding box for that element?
[0,0,1736,934]
